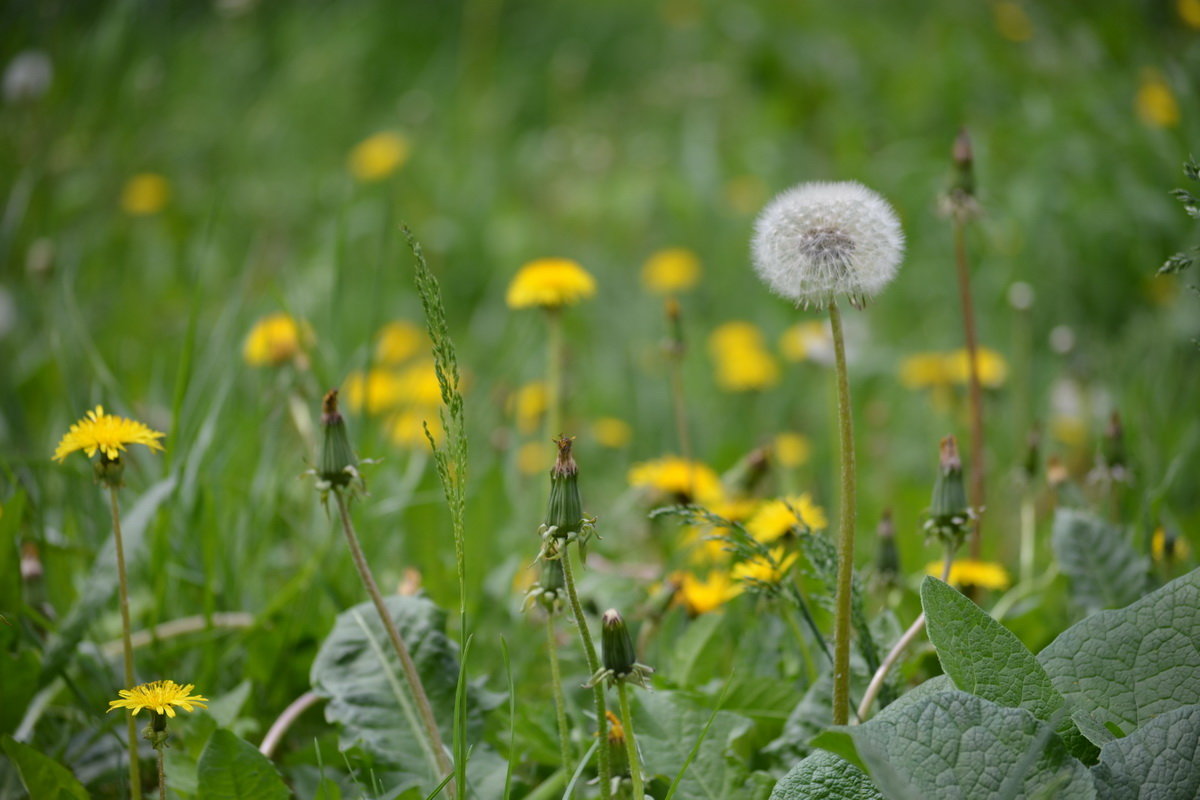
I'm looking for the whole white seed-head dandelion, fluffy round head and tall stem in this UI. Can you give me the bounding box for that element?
[752,181,904,724]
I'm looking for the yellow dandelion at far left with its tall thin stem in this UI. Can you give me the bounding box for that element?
[54,405,164,800]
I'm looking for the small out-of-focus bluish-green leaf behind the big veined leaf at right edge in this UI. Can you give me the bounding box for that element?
[1051,509,1150,613]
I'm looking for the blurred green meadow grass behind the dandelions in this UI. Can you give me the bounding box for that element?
[0,0,1200,796]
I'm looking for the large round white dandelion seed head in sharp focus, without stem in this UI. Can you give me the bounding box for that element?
[751,181,904,306]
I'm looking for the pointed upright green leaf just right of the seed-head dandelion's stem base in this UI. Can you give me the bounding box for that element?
[920,577,1097,763]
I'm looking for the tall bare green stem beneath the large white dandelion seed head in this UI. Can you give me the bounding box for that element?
[829,300,857,724]
